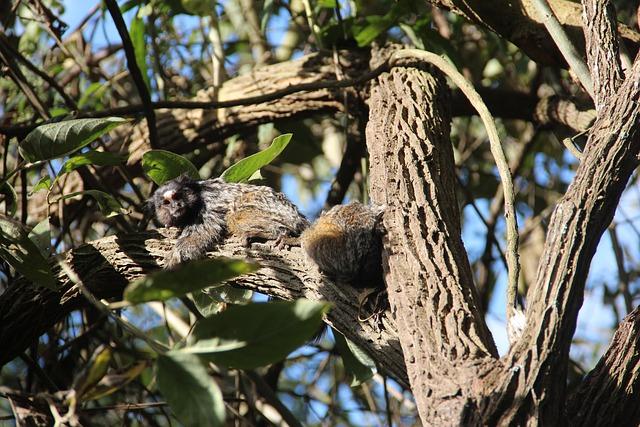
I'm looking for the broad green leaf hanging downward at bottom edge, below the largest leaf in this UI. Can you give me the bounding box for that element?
[157,352,225,427]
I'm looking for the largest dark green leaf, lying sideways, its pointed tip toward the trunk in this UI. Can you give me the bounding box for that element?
[179,299,330,369]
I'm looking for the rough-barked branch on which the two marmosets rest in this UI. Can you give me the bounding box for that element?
[0,229,409,388]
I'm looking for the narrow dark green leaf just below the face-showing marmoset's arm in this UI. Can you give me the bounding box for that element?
[124,258,259,304]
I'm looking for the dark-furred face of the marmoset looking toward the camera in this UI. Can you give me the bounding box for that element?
[153,181,201,227]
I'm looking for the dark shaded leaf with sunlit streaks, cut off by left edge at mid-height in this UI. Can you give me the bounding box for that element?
[0,217,56,289]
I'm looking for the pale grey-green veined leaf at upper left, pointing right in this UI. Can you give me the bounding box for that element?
[20,117,128,162]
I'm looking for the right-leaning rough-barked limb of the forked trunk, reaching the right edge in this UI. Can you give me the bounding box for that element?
[487,54,640,425]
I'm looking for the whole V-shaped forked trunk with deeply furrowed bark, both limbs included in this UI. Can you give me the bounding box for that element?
[367,42,640,425]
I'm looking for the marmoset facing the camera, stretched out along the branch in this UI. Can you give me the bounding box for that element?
[151,175,309,268]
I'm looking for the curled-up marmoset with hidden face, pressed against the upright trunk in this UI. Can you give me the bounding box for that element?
[300,202,384,288]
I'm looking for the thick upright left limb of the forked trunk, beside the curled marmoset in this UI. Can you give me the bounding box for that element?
[367,50,497,425]
